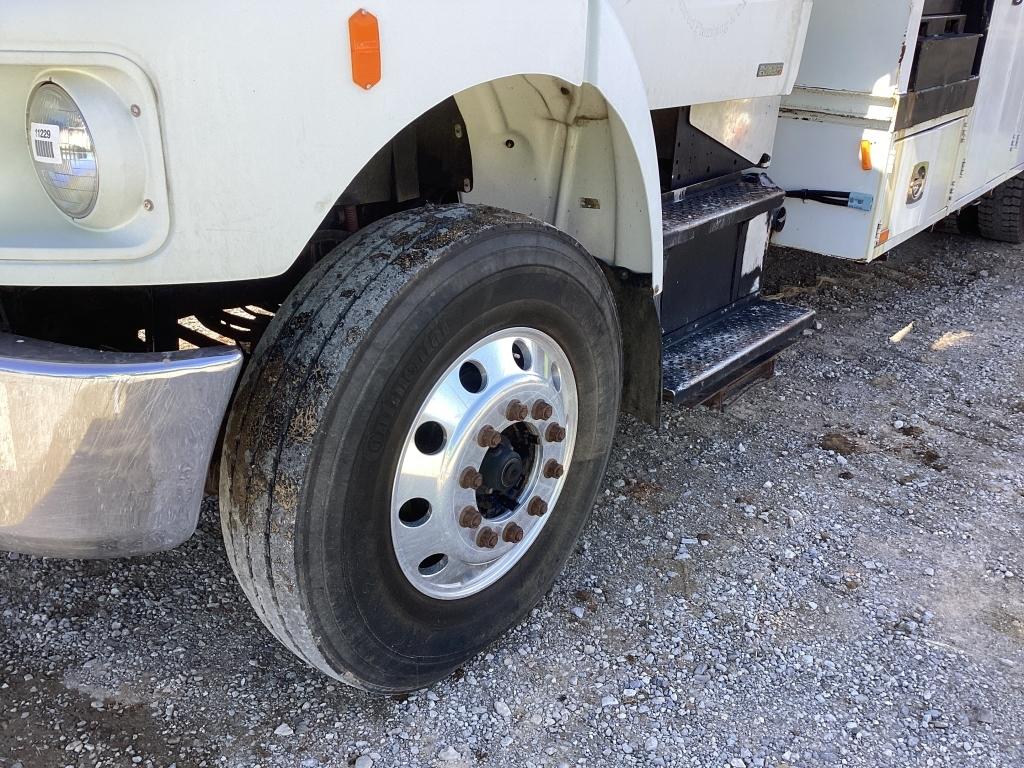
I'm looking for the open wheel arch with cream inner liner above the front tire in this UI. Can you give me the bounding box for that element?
[335,75,652,273]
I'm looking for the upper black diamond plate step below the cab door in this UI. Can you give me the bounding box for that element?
[662,173,785,249]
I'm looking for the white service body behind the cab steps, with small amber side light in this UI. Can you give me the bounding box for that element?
[772,0,1024,261]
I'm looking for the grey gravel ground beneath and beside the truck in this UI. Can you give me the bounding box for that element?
[0,234,1024,768]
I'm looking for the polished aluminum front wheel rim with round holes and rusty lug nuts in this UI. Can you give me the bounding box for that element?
[391,328,579,600]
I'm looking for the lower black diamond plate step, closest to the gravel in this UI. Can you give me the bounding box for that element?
[662,299,814,406]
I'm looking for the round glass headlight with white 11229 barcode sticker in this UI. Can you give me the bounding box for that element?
[28,83,99,219]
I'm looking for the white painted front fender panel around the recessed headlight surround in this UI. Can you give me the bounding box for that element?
[0,0,593,285]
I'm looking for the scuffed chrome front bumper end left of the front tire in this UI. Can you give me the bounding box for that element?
[0,334,242,558]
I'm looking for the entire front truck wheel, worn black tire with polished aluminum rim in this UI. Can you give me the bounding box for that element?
[220,205,622,693]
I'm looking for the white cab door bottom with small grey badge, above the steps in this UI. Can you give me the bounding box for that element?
[608,0,811,110]
